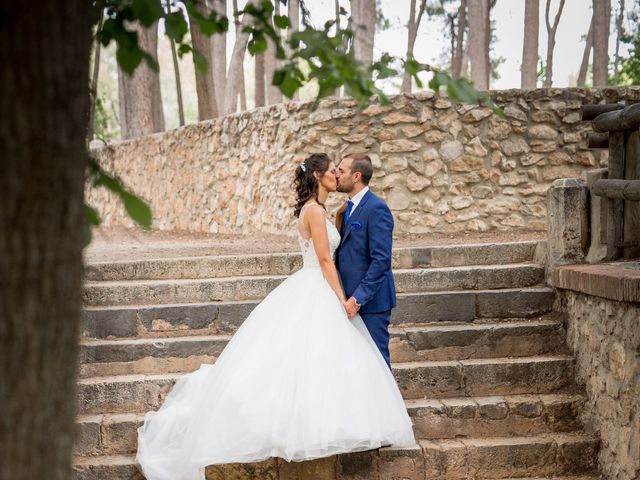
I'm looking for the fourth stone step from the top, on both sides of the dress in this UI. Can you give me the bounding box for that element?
[80,315,567,378]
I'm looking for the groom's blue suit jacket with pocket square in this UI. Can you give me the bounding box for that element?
[336,191,396,313]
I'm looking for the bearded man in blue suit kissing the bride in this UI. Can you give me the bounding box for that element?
[336,153,396,367]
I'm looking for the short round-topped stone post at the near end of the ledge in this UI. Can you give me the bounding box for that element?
[546,178,589,284]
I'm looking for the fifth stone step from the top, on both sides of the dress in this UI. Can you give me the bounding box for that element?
[78,355,574,414]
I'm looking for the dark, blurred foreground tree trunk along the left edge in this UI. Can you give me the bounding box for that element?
[0,0,92,480]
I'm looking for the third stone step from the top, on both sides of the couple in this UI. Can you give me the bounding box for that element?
[82,287,555,338]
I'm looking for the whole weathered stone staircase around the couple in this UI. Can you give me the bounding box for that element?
[74,241,598,480]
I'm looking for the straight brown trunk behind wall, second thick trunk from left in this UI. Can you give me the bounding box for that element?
[189,0,219,120]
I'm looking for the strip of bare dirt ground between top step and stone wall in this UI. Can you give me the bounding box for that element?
[84,228,546,263]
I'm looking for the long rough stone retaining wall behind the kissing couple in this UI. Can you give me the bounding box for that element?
[88,89,640,233]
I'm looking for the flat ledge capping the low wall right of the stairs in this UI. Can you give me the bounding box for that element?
[551,260,640,303]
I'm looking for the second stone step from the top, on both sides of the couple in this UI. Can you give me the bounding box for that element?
[83,263,544,306]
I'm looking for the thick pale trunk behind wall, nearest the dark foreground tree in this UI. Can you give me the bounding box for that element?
[118,22,164,140]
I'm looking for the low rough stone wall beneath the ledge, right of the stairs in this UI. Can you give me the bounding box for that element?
[558,290,640,480]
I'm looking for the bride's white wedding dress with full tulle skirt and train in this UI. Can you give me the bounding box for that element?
[136,203,415,480]
